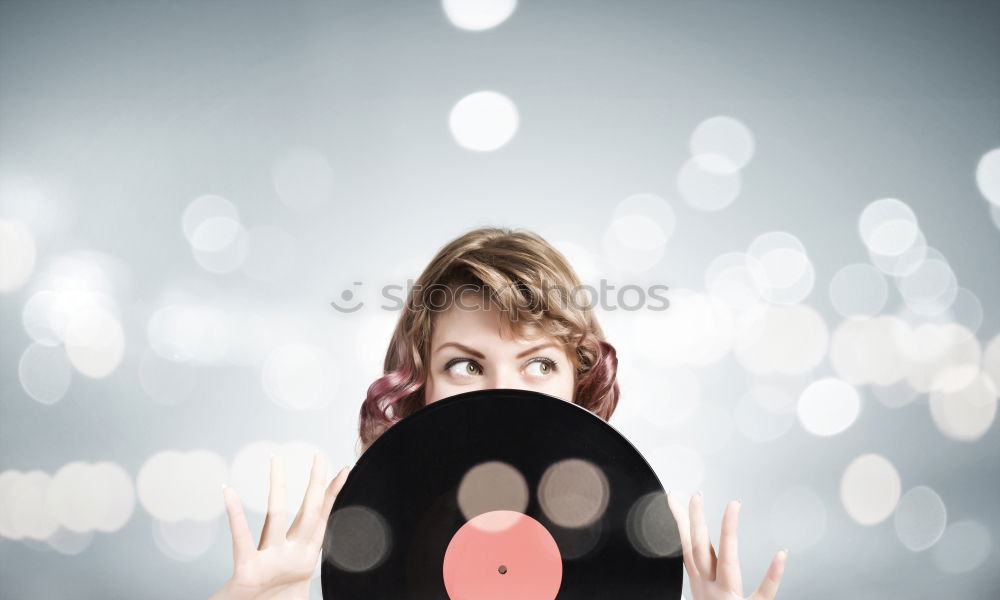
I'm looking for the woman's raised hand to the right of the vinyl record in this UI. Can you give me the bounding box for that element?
[667,492,788,600]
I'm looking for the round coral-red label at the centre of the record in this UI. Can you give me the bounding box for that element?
[443,510,562,600]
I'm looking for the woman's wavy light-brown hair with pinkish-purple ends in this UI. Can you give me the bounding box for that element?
[358,227,619,453]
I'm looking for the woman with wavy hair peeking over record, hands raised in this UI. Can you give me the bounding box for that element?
[213,227,787,600]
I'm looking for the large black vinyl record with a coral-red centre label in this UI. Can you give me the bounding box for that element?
[321,389,683,600]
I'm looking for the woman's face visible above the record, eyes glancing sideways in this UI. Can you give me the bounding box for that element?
[424,292,575,404]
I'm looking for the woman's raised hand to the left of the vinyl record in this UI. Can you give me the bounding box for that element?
[210,452,350,600]
